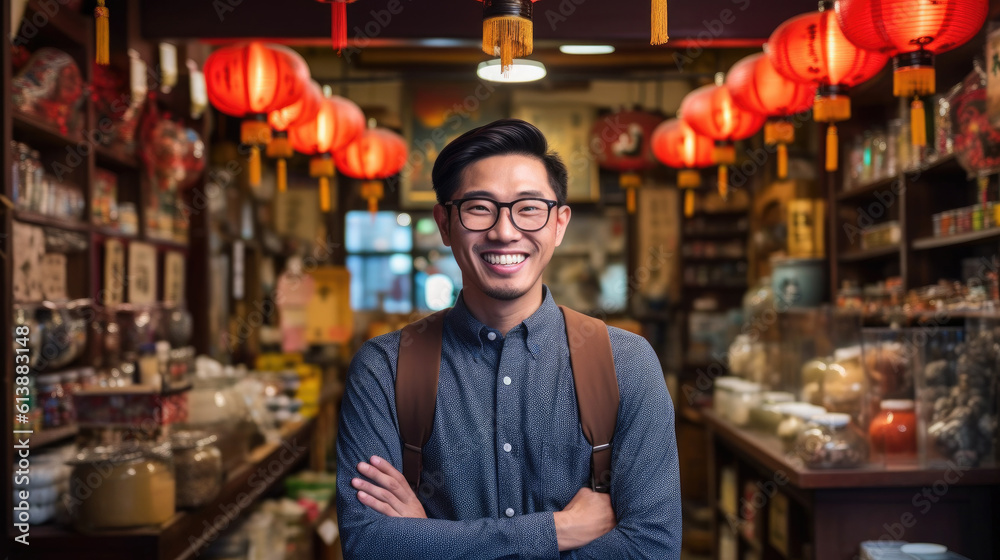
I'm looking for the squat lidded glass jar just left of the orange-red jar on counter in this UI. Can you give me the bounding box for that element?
[795,413,868,469]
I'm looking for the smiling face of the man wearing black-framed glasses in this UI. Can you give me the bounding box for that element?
[434,155,570,301]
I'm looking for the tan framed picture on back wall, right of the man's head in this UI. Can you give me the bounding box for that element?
[512,103,600,202]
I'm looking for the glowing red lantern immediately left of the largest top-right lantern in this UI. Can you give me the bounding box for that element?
[765,4,888,171]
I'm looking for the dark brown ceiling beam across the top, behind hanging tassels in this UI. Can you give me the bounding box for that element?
[142,0,816,48]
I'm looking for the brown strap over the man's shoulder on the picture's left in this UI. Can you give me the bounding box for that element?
[396,309,448,492]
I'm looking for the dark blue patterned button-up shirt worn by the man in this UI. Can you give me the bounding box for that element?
[337,288,681,560]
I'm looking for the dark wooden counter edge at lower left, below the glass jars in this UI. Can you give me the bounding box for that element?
[31,419,315,560]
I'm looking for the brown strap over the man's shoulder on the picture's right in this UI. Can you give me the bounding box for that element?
[559,305,620,492]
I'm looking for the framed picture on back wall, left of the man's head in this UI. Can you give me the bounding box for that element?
[400,81,510,208]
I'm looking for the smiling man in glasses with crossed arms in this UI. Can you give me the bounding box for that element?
[337,119,681,560]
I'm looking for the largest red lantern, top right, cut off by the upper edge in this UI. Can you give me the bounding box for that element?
[837,0,989,146]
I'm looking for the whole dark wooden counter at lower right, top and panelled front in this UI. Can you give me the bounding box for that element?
[701,410,1000,560]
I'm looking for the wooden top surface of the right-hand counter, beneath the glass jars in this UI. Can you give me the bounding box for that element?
[701,409,1000,489]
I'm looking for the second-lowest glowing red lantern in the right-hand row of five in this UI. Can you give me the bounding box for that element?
[678,85,764,198]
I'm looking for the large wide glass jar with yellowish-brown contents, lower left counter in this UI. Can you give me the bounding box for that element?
[69,442,176,532]
